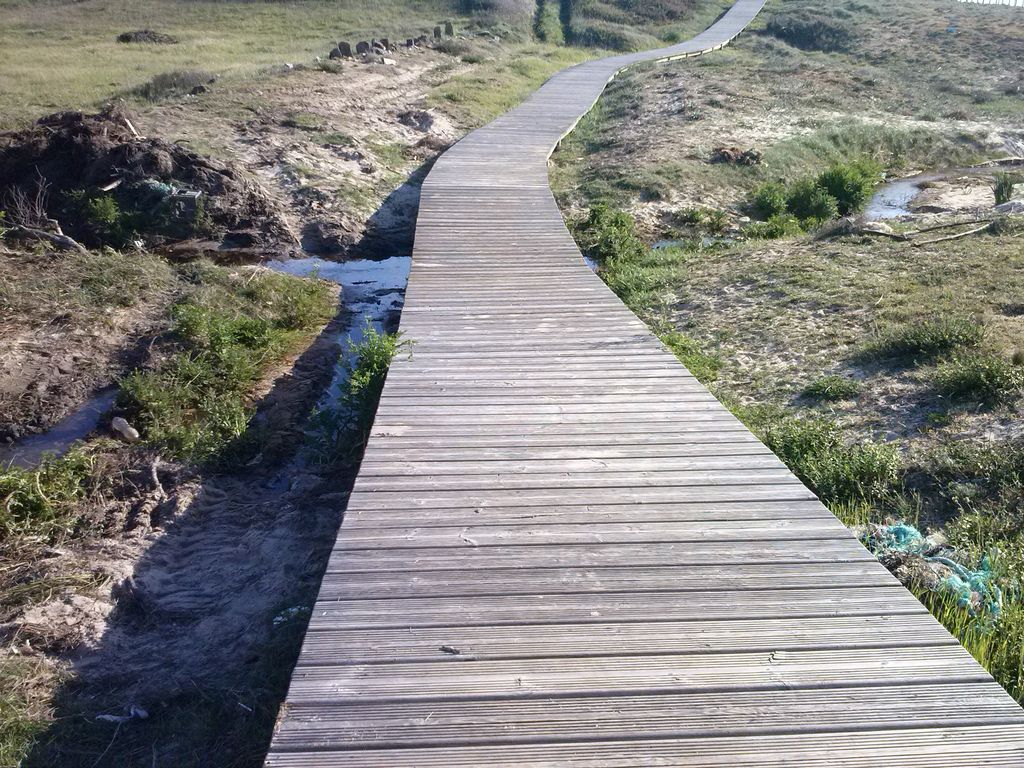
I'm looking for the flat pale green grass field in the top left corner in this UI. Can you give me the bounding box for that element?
[0,0,460,128]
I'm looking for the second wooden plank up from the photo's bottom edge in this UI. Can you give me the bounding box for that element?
[272,683,1024,750]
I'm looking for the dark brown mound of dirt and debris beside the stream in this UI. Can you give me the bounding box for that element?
[0,105,295,248]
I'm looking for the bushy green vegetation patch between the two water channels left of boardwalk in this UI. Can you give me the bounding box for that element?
[120,264,333,461]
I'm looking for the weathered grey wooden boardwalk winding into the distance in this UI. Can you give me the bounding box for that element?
[267,0,1024,768]
